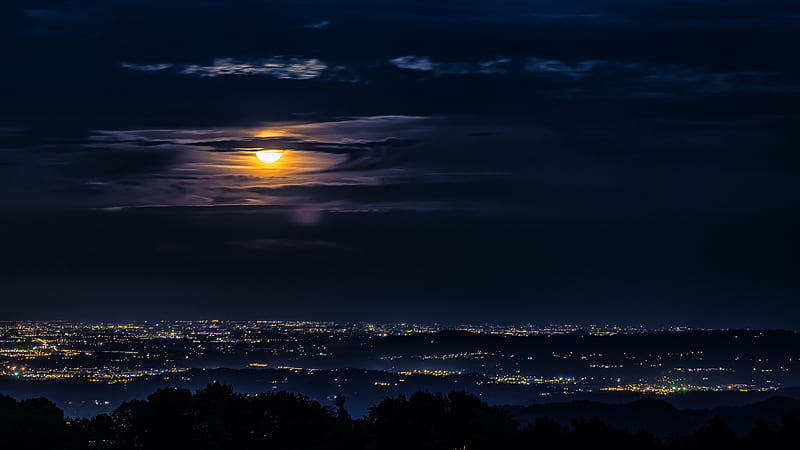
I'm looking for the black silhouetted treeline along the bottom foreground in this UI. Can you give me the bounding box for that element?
[0,383,800,450]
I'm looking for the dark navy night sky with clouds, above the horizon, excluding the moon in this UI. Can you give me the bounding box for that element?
[0,0,800,329]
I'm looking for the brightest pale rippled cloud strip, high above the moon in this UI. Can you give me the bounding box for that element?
[180,56,328,80]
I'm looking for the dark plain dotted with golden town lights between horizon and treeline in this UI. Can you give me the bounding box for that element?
[0,321,800,416]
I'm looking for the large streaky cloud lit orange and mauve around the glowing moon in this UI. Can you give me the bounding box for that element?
[59,116,440,207]
